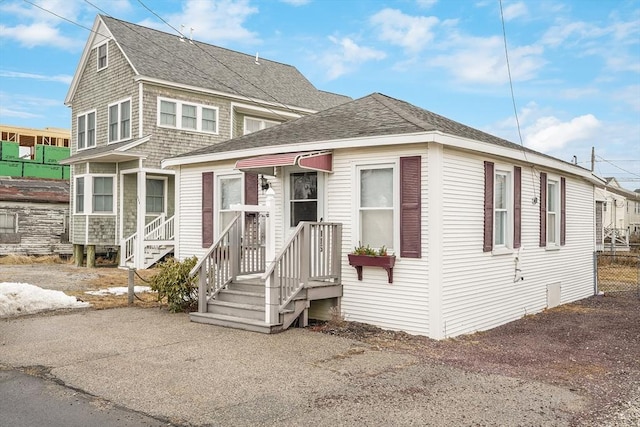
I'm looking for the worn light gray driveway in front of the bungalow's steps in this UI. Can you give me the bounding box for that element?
[0,308,585,426]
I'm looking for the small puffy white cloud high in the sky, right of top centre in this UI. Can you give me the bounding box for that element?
[370,8,439,53]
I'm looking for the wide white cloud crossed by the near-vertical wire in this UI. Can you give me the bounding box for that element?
[428,36,545,84]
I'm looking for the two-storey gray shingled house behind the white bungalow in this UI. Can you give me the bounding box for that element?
[64,15,349,268]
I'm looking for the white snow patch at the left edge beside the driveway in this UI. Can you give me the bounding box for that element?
[0,282,90,317]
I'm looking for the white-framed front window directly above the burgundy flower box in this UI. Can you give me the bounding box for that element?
[356,164,396,249]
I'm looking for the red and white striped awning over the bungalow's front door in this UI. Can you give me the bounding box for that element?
[236,151,333,176]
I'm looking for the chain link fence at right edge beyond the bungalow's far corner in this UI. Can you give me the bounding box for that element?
[596,252,640,298]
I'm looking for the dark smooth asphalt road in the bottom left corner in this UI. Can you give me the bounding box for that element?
[0,370,169,427]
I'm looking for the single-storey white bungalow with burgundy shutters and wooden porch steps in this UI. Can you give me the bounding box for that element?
[162,93,603,339]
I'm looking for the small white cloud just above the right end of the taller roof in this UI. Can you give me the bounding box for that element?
[320,36,386,80]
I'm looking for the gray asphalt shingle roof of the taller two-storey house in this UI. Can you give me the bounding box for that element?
[100,15,351,111]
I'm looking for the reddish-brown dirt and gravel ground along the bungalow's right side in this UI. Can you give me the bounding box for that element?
[312,293,640,425]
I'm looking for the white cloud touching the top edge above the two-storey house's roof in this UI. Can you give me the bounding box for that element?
[140,0,258,44]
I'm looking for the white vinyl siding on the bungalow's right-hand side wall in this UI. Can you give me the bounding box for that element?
[439,148,595,337]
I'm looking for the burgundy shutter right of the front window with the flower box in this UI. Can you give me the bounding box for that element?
[400,156,422,258]
